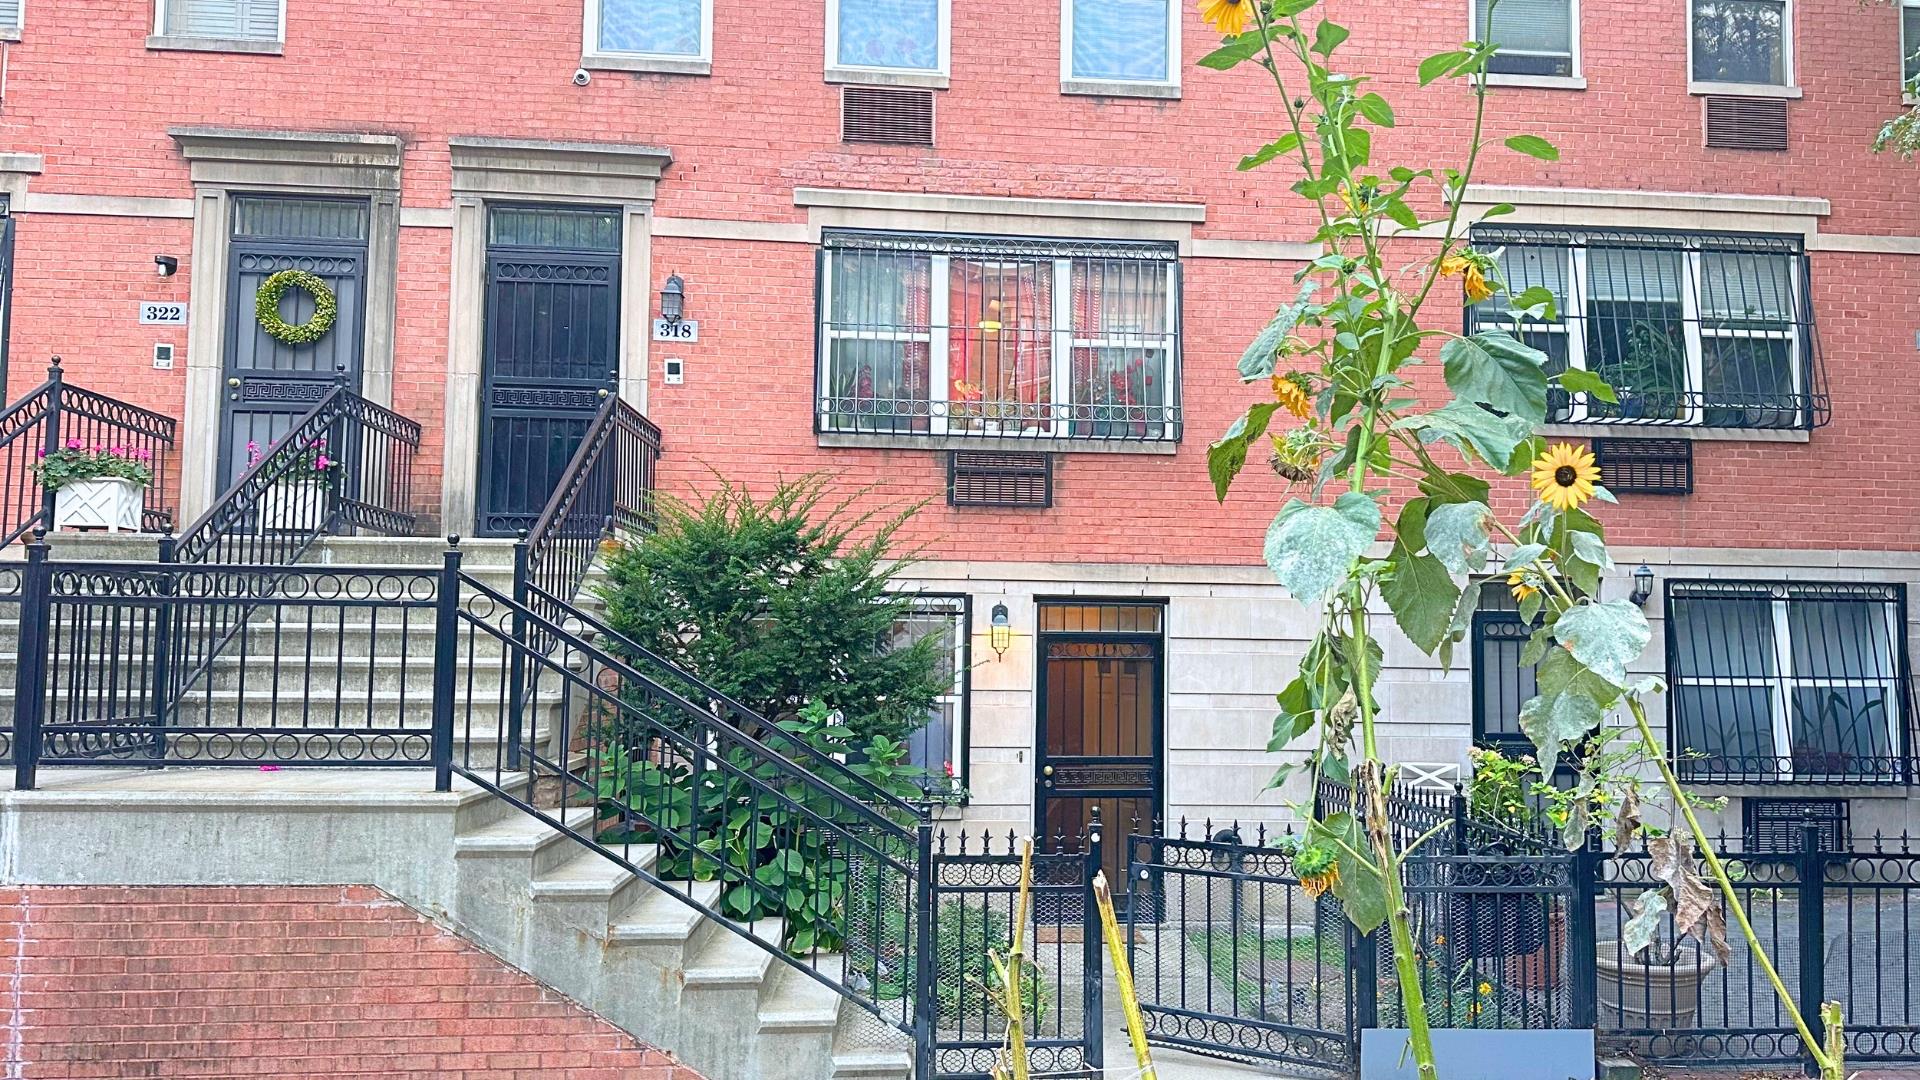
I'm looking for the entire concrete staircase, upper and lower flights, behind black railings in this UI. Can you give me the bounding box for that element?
[0,536,912,1080]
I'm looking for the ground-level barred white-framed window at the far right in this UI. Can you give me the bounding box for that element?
[1667,580,1912,784]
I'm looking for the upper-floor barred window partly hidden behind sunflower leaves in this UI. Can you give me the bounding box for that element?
[1467,227,1830,429]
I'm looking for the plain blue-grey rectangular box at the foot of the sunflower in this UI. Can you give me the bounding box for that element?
[1359,1028,1594,1080]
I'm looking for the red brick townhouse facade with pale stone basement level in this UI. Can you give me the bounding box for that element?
[0,0,1920,834]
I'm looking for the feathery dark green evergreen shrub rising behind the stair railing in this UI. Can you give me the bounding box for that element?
[601,477,950,742]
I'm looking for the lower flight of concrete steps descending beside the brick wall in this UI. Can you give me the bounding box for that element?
[447,807,912,1080]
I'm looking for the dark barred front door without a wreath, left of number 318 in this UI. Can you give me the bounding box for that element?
[478,206,620,536]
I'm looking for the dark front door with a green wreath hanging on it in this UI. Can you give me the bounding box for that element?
[219,196,369,492]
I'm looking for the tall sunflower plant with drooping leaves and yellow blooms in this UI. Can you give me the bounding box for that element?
[1200,0,1843,1080]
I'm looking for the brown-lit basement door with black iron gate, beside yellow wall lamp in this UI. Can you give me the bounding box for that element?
[1035,601,1165,899]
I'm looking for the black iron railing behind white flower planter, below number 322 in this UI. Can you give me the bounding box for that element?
[0,356,179,548]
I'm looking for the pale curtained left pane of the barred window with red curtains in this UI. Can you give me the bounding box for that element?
[828,252,931,430]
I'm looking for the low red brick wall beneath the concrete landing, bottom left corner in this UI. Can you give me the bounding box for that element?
[0,886,699,1080]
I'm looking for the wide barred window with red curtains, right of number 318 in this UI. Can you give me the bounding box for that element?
[818,233,1181,442]
